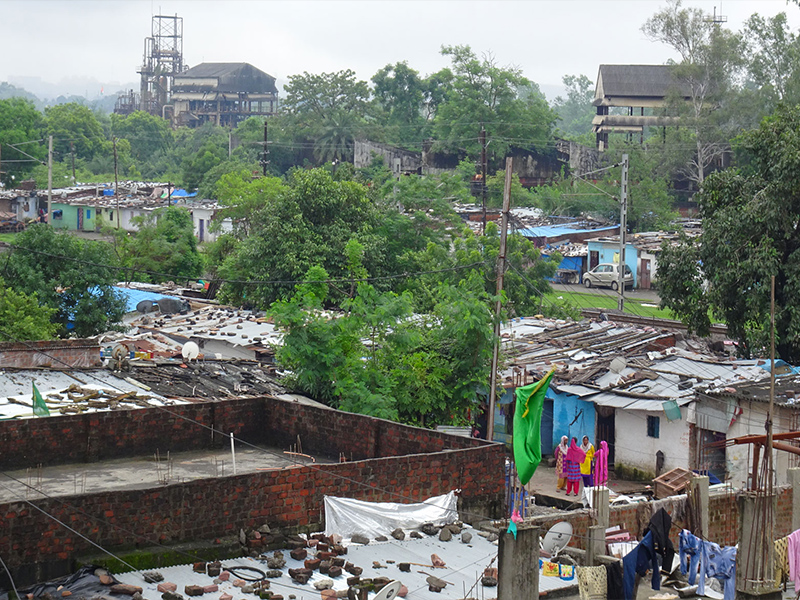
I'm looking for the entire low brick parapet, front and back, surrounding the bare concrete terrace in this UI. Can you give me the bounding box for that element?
[0,399,505,582]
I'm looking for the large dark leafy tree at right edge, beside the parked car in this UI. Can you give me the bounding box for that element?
[658,107,800,364]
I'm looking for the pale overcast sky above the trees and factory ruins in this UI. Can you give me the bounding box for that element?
[0,0,800,97]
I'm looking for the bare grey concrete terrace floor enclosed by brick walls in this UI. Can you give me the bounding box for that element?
[0,444,334,503]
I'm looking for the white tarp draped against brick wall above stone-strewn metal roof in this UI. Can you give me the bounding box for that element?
[325,491,458,538]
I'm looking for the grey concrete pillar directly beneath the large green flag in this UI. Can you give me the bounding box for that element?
[497,525,539,600]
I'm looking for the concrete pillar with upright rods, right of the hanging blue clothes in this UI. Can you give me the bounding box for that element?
[736,492,781,600]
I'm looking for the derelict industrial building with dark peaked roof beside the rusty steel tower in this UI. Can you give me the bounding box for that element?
[172,63,278,127]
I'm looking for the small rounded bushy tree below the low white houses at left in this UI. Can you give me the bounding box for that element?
[121,206,203,282]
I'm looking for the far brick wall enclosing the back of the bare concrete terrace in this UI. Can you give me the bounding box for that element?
[0,398,486,469]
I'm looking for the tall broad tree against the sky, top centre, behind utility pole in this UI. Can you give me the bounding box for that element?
[434,46,556,157]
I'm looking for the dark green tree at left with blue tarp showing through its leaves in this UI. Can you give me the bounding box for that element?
[6,224,125,337]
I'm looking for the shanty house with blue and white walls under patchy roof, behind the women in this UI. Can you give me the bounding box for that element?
[502,318,768,479]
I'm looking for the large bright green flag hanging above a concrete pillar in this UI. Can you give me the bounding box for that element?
[513,370,555,485]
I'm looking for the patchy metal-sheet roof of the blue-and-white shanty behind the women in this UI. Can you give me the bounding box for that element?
[502,318,768,410]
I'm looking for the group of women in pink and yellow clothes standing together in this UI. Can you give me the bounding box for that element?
[555,435,608,496]
